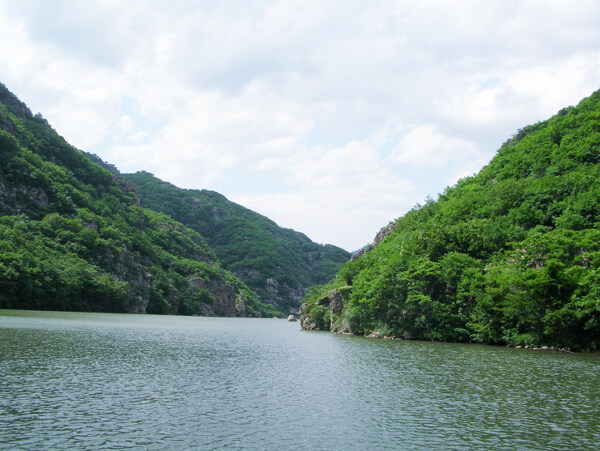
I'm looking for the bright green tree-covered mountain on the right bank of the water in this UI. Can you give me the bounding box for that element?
[301,87,600,349]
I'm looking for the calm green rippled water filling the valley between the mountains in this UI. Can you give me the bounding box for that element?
[0,311,600,450]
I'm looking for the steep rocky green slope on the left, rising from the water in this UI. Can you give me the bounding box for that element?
[0,84,274,316]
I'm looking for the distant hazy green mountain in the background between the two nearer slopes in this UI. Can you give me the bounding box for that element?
[123,172,350,313]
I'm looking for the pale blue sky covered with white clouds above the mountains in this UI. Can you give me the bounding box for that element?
[0,0,600,251]
